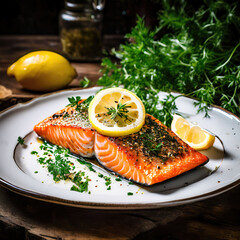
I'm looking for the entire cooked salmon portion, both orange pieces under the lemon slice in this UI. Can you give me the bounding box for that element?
[34,99,208,185]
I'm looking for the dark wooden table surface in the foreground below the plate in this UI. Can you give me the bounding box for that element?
[0,187,240,240]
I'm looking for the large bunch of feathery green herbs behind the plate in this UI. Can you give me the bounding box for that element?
[98,0,240,126]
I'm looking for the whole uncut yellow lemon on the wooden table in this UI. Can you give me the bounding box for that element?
[7,51,77,91]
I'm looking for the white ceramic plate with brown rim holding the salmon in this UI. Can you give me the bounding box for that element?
[0,88,240,209]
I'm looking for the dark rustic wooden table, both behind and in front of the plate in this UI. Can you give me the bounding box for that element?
[0,36,240,240]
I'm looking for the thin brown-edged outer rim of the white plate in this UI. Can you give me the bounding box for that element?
[0,86,240,210]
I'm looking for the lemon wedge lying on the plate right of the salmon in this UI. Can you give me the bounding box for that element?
[171,115,215,150]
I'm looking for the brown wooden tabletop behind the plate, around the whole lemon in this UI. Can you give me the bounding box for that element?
[0,35,123,111]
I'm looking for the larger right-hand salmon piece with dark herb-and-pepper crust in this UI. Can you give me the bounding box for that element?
[94,114,208,185]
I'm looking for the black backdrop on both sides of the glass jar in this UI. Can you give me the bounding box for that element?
[0,0,160,35]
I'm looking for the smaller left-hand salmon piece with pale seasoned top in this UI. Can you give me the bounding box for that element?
[34,100,95,157]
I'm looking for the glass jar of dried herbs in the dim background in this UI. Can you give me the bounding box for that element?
[59,0,102,61]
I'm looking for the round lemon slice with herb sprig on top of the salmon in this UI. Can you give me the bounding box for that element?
[88,87,145,137]
